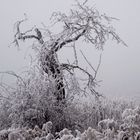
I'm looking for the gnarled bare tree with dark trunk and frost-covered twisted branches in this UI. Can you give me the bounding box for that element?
[13,1,126,102]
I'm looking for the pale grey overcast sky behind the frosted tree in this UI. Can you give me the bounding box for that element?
[0,0,140,98]
